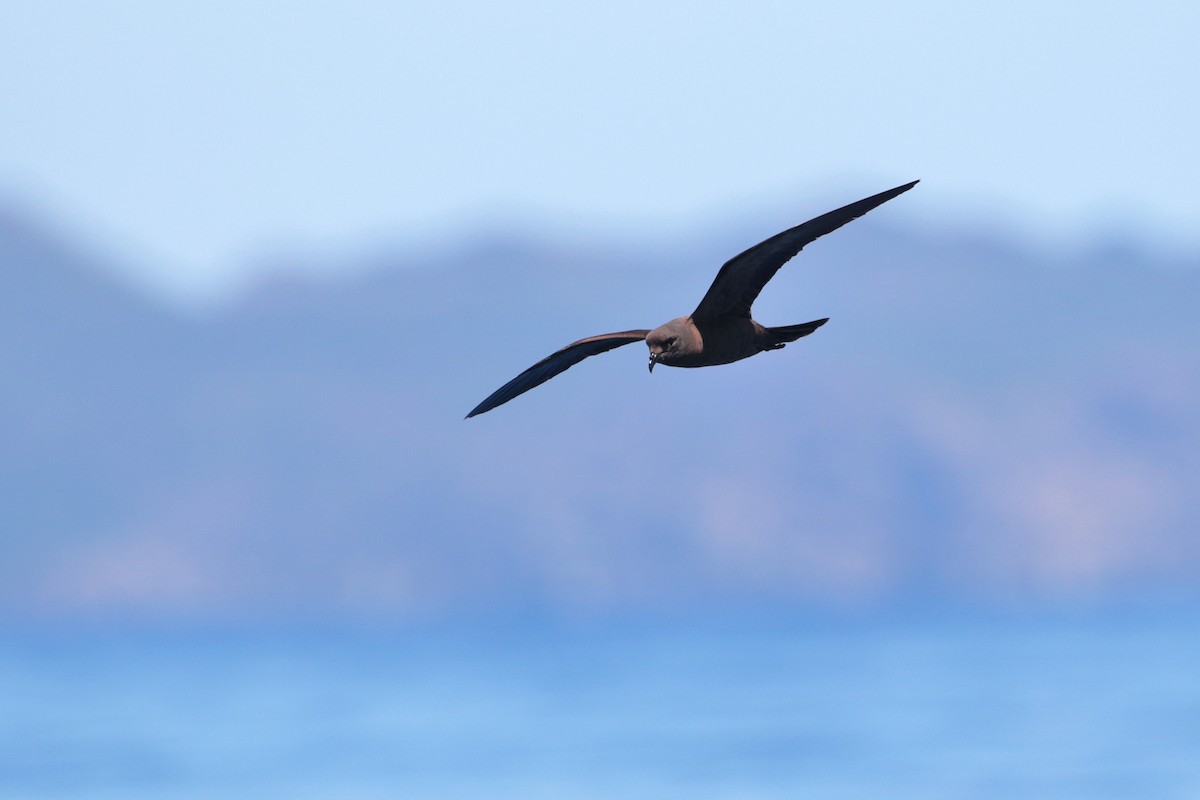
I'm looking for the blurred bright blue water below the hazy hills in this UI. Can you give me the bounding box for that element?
[0,619,1200,800]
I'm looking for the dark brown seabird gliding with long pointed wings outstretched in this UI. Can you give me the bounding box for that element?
[467,181,918,419]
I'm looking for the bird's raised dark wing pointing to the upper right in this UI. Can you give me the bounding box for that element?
[691,181,919,319]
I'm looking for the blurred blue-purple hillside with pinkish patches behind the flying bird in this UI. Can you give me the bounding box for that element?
[0,201,1200,619]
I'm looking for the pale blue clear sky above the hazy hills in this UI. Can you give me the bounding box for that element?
[0,0,1200,294]
